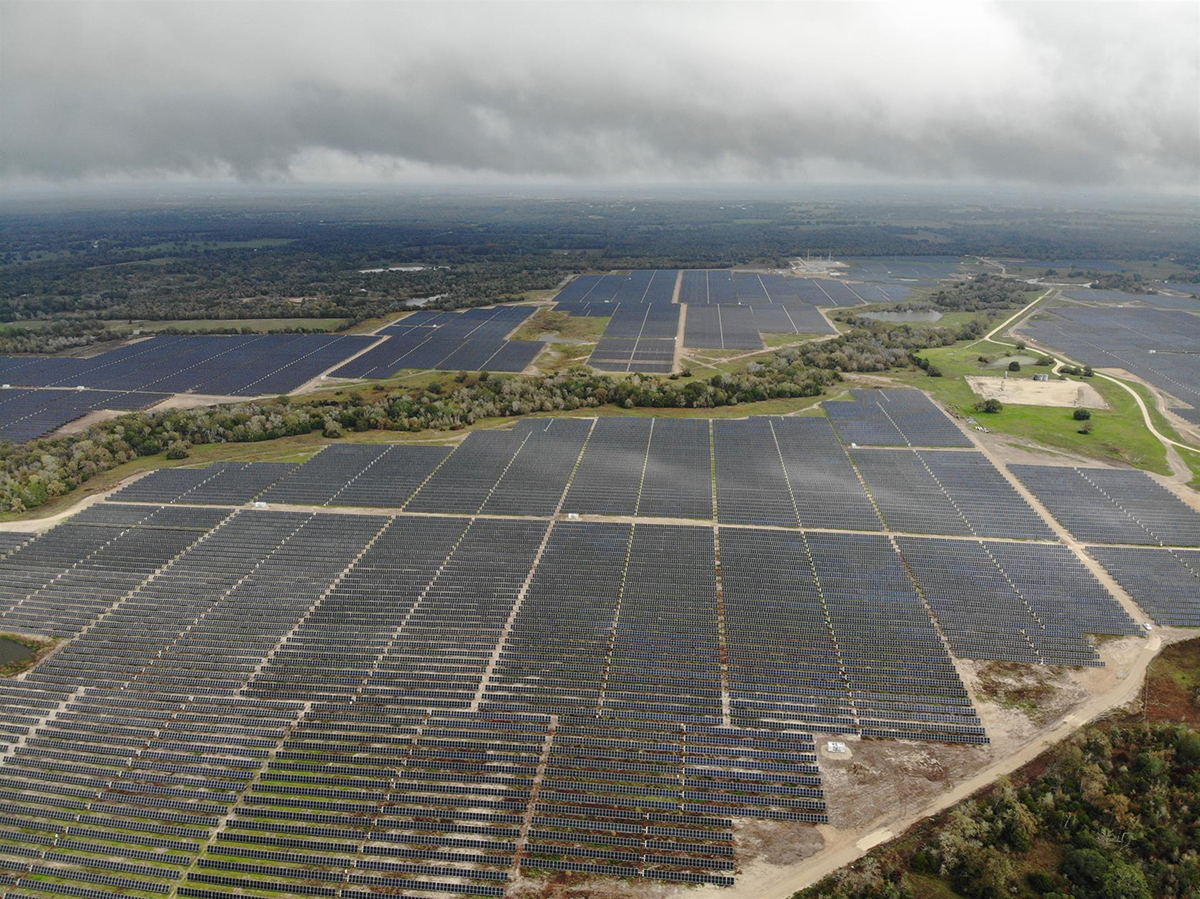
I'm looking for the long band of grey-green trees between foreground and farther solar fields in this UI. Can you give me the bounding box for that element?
[0,322,980,513]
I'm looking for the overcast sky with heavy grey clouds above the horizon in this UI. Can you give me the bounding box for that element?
[0,0,1200,192]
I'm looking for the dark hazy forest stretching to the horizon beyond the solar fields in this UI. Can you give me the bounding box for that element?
[0,194,1200,352]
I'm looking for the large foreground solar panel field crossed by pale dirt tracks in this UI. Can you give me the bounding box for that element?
[0,391,1200,899]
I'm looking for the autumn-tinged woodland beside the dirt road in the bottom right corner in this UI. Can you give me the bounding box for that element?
[793,640,1200,899]
